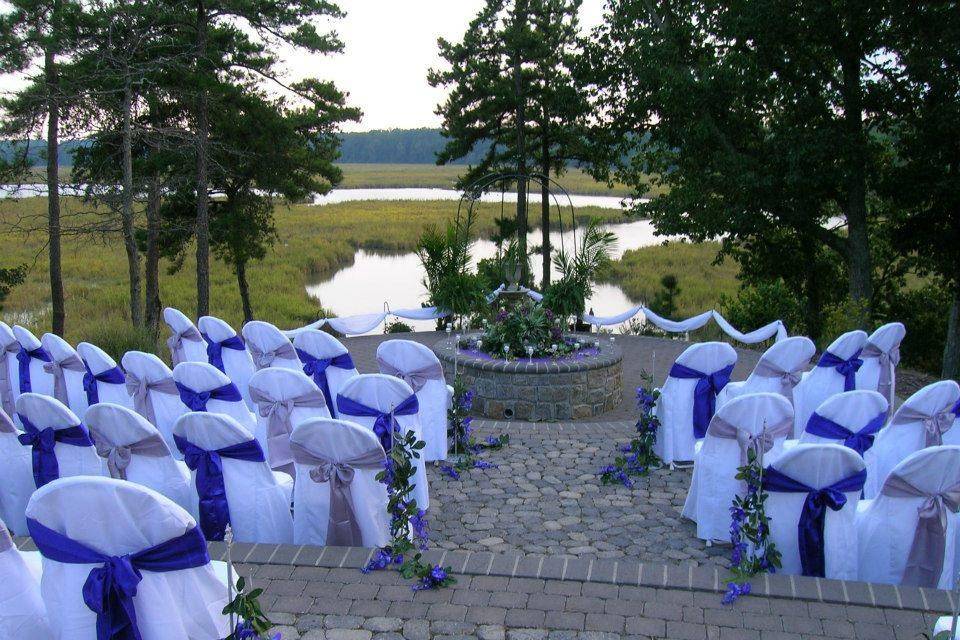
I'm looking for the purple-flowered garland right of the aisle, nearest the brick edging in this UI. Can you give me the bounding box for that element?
[723,448,780,604]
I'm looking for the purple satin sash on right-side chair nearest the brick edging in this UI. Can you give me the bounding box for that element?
[763,467,867,578]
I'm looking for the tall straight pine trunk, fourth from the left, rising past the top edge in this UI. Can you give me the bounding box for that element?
[196,0,210,318]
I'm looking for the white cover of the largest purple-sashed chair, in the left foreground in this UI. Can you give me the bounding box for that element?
[27,477,231,640]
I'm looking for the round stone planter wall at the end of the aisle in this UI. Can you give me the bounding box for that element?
[433,334,623,422]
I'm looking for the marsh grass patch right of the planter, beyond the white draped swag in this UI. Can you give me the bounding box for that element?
[599,242,740,319]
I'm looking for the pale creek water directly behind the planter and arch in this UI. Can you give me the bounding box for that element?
[307,220,667,331]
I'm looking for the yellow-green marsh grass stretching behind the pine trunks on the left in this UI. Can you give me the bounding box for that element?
[0,198,621,355]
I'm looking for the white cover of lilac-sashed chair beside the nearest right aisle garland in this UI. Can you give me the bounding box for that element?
[683,393,793,540]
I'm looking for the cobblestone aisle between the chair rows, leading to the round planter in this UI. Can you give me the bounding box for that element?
[428,422,725,564]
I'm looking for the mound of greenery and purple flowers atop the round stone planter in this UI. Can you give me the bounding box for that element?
[457,300,595,360]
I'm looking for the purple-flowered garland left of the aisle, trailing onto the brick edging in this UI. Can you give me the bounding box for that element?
[361,423,456,591]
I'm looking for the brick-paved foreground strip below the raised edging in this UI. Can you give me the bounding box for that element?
[239,565,937,640]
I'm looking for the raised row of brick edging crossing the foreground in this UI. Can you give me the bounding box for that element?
[14,536,954,613]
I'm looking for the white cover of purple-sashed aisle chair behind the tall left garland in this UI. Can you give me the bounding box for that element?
[338,372,430,510]
